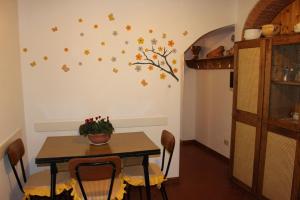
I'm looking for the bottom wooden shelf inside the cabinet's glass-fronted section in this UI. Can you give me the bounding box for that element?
[268,118,300,132]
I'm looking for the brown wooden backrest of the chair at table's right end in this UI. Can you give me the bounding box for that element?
[161,130,175,178]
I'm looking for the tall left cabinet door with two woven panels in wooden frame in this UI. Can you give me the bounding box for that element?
[231,40,265,192]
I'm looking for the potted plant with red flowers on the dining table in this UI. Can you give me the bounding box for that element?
[79,116,114,144]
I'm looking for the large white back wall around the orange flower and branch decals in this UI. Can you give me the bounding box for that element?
[19,0,235,176]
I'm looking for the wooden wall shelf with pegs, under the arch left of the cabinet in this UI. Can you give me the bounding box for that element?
[185,56,234,70]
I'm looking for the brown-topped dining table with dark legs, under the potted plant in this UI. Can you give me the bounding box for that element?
[35,132,160,200]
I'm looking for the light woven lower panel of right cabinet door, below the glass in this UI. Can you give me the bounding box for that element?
[262,132,297,200]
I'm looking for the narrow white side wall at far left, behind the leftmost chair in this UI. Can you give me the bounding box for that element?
[0,0,27,200]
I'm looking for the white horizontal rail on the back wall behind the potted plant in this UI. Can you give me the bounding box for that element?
[34,117,168,132]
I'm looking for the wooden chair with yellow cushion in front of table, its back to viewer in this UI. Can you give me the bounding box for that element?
[69,156,126,200]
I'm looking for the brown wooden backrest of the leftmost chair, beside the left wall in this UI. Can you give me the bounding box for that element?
[6,138,26,193]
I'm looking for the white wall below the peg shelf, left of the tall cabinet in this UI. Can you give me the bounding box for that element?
[195,70,233,157]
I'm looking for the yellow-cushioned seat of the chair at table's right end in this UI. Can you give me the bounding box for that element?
[123,163,165,186]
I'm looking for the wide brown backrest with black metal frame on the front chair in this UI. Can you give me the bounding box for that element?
[69,156,121,200]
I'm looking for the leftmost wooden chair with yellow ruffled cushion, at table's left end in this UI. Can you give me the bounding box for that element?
[6,138,72,199]
